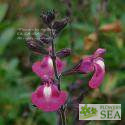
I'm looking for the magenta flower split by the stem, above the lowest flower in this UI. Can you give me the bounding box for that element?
[32,56,65,80]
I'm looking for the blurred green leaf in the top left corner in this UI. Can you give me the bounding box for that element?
[0,4,8,22]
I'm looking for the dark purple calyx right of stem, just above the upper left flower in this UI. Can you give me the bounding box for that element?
[56,48,71,58]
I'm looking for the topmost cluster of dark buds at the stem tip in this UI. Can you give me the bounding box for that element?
[40,10,55,26]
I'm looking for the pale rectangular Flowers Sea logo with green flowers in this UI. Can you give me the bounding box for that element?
[79,104,121,120]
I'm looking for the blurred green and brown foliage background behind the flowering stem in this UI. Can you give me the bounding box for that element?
[0,0,125,125]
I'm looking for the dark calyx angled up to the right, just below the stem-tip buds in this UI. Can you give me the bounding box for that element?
[52,18,69,34]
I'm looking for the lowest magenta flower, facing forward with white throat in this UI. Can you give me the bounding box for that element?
[31,84,68,112]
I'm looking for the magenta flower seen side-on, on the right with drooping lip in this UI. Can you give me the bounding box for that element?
[78,48,105,88]
